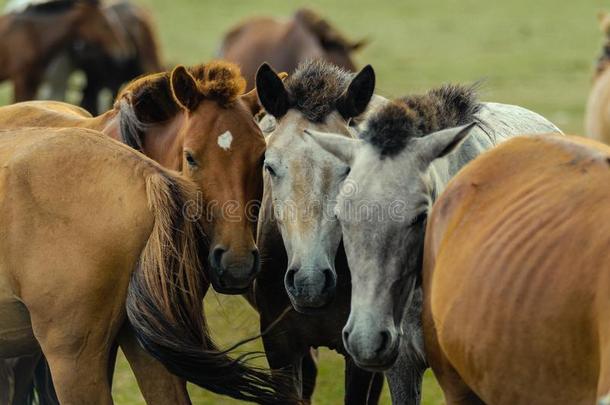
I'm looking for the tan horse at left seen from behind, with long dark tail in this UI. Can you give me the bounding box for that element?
[0,128,287,404]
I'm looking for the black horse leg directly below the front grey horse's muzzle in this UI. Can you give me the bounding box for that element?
[345,356,383,405]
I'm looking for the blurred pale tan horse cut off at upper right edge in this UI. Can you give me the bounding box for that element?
[585,12,610,143]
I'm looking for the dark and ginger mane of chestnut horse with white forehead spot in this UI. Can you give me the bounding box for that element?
[115,61,246,151]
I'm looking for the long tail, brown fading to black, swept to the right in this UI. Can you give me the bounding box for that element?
[126,172,291,404]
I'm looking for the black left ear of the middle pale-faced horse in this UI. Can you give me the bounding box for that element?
[256,63,289,118]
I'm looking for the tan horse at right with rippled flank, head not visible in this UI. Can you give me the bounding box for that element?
[423,135,610,405]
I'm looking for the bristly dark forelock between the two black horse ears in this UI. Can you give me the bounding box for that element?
[284,59,353,122]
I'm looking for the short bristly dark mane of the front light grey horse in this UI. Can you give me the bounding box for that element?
[360,85,481,156]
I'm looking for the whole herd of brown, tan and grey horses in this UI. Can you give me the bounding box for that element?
[0,0,610,405]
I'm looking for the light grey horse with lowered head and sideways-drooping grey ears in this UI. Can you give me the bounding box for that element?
[306,85,559,403]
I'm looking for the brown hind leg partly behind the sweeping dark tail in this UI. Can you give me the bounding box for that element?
[118,323,191,405]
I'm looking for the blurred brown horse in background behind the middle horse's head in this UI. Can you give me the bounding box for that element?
[218,8,366,89]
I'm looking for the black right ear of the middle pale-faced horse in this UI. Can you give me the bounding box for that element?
[337,65,375,120]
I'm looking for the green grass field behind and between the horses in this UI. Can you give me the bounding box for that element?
[0,0,604,405]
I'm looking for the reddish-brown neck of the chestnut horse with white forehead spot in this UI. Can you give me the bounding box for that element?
[142,112,185,171]
